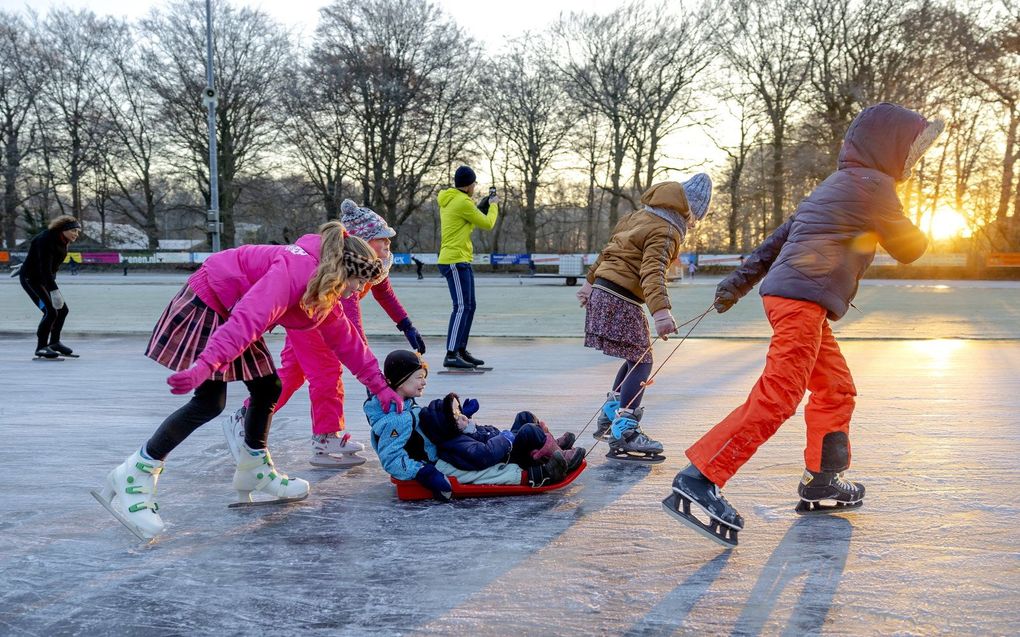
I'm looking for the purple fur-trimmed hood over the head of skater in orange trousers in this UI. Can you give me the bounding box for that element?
[838,102,946,181]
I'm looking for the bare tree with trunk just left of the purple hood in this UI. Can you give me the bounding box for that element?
[726,0,811,228]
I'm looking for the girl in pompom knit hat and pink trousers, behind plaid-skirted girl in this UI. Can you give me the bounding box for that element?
[223,199,425,469]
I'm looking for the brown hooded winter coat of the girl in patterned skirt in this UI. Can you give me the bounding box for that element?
[588,181,691,313]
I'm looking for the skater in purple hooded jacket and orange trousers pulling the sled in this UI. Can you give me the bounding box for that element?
[673,103,944,529]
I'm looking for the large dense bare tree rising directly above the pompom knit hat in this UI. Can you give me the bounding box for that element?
[312,0,477,233]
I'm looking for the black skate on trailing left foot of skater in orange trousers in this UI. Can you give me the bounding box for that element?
[662,467,744,548]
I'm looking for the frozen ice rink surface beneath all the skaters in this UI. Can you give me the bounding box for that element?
[0,272,1020,636]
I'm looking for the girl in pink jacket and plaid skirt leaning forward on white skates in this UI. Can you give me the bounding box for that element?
[93,221,402,539]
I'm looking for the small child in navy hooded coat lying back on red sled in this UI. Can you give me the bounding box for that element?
[418,392,584,482]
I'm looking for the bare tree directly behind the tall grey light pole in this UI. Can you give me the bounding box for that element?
[141,0,291,248]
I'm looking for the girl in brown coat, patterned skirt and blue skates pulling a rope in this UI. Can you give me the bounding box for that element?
[577,173,712,463]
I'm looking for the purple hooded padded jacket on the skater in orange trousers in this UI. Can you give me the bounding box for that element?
[718,103,928,320]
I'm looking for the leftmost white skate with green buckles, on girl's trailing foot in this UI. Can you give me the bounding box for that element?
[92,449,164,540]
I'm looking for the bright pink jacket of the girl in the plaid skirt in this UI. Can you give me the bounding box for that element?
[188,234,386,393]
